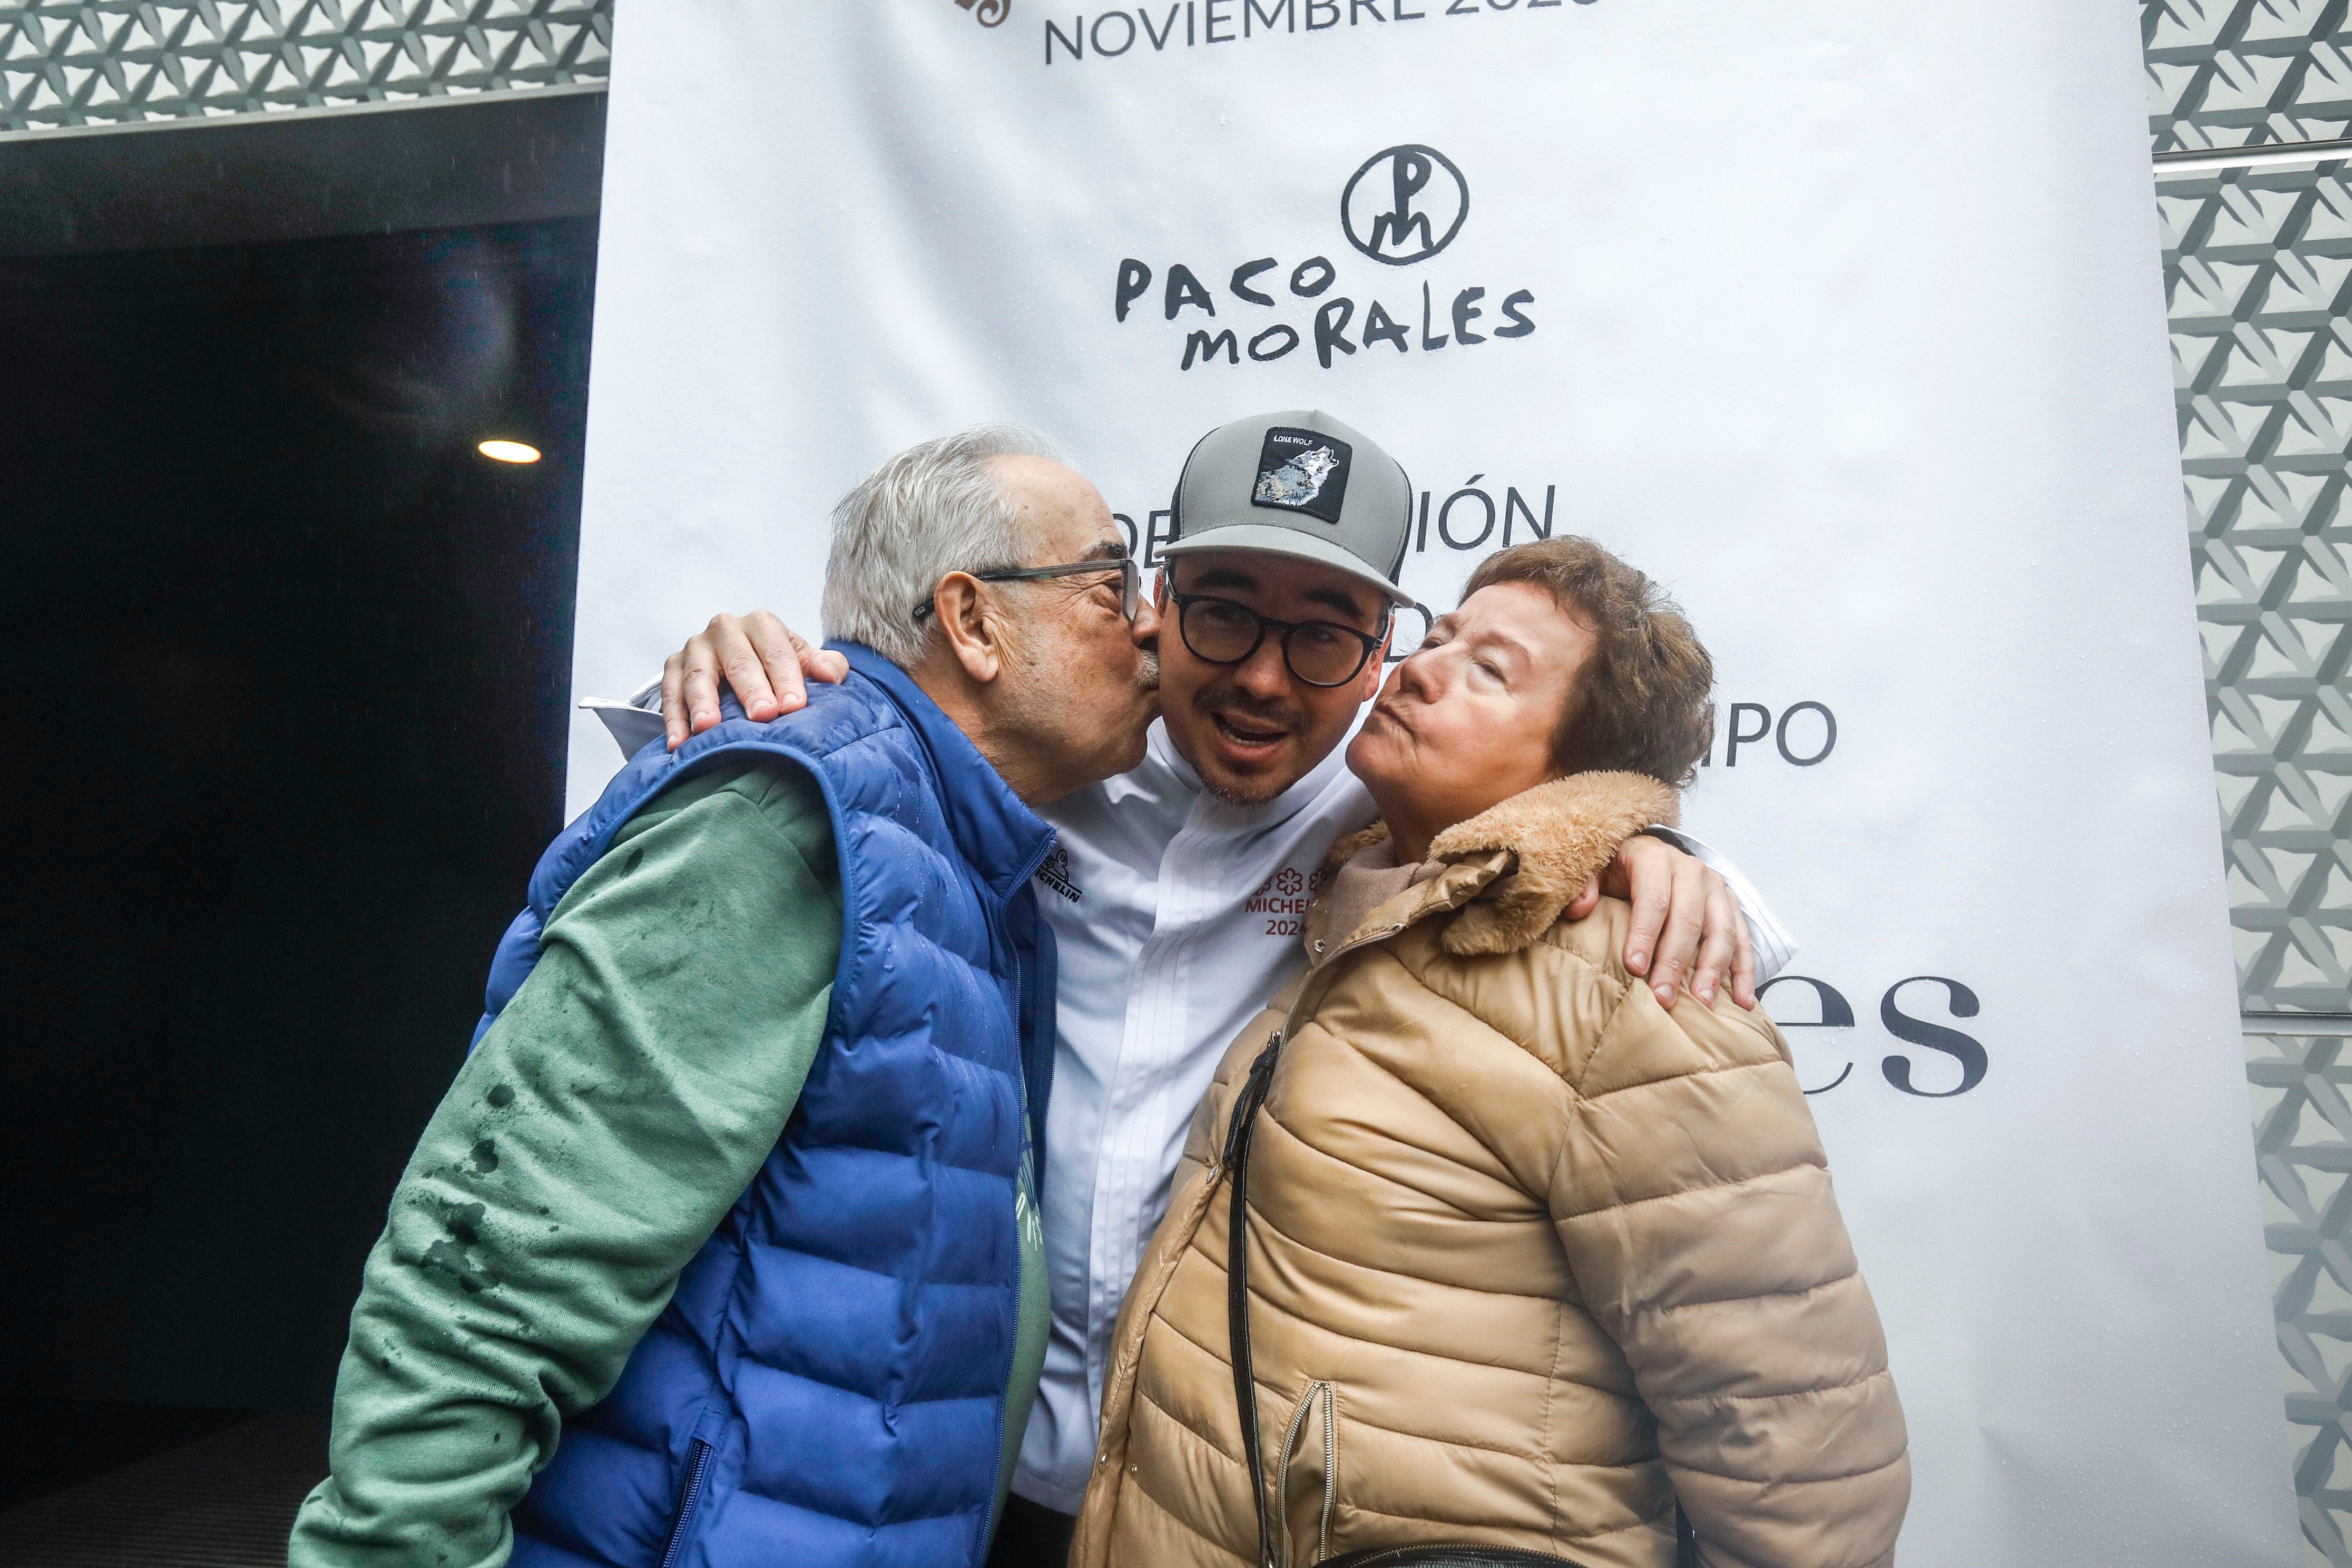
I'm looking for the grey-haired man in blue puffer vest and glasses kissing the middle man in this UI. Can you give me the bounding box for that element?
[289,428,1157,1568]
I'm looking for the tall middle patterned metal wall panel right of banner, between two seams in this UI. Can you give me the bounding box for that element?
[2157,164,2352,1013]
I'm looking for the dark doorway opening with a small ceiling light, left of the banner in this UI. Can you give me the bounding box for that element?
[0,219,595,1413]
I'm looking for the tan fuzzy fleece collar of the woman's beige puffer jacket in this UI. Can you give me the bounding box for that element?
[1308,773,1679,962]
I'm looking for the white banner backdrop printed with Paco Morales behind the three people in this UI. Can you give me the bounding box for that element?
[572,0,2298,1568]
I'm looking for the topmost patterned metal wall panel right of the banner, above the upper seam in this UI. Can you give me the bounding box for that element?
[2140,0,2352,153]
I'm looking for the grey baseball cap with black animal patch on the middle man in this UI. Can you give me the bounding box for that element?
[1160,409,1414,604]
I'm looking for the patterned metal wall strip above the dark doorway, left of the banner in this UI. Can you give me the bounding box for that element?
[0,0,612,134]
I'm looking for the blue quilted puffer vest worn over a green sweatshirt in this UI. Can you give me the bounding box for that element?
[475,644,1054,1568]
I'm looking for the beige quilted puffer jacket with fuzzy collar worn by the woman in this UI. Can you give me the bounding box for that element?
[1070,773,1910,1568]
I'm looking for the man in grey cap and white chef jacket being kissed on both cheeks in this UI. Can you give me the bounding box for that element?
[616,411,1792,1568]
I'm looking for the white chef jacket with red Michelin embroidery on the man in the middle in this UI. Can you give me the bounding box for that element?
[1014,724,1795,1514]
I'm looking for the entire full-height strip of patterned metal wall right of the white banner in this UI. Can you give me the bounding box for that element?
[2143,0,2352,1568]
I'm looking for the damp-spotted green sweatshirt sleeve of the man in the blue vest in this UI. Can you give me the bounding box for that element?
[289,762,842,1568]
